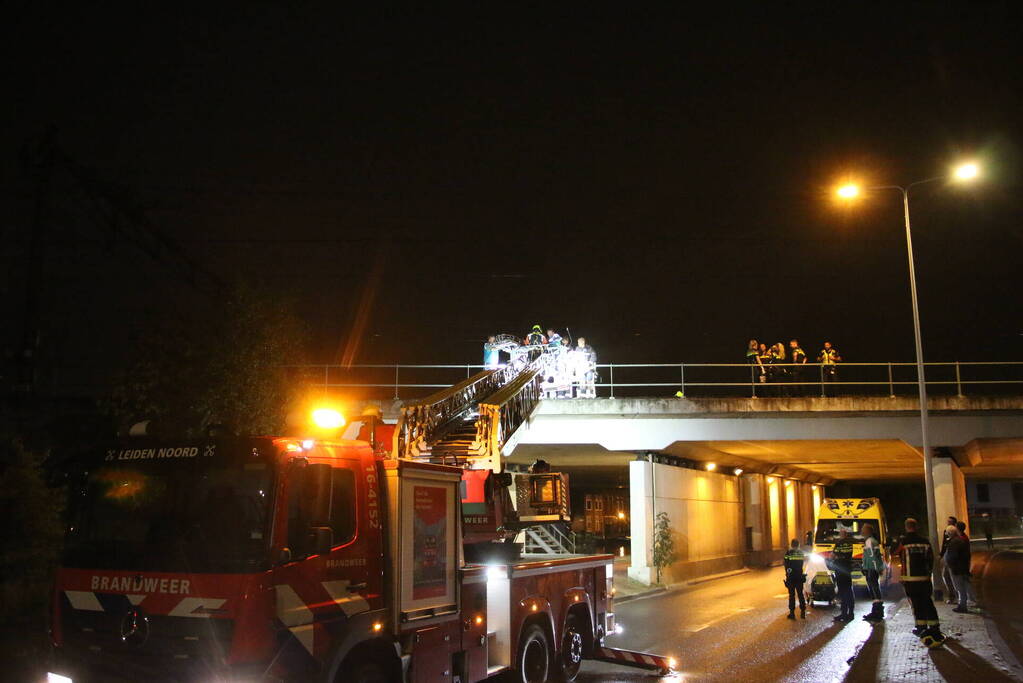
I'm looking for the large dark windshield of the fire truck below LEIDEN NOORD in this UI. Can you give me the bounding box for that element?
[63,462,273,574]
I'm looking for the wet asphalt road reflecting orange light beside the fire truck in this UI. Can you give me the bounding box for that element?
[578,567,901,683]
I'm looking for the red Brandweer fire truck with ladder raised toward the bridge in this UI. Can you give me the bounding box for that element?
[49,359,674,683]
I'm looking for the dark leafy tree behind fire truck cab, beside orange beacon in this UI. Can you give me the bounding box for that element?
[112,284,307,436]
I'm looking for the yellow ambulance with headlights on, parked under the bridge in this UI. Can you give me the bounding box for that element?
[813,498,888,590]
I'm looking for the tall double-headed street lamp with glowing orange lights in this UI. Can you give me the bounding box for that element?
[836,162,980,589]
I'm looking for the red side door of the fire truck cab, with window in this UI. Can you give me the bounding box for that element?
[273,459,383,662]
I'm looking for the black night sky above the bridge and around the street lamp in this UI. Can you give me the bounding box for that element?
[0,2,1023,394]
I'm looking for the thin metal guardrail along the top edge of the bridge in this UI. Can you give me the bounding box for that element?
[290,361,1023,399]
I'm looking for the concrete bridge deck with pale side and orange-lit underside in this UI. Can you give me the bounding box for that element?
[507,396,1023,484]
